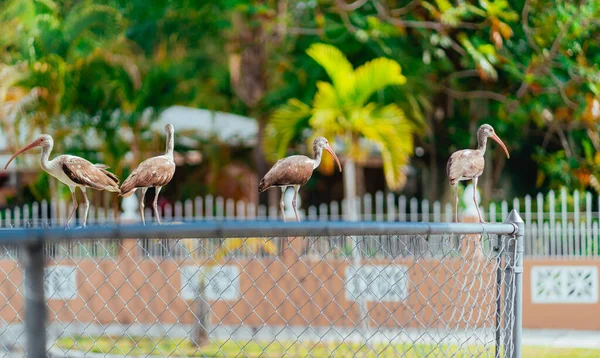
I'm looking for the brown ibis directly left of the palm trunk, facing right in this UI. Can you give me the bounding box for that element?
[258,137,342,221]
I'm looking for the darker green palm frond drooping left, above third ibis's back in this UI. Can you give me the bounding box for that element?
[262,99,311,161]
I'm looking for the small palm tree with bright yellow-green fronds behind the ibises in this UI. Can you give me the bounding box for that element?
[264,44,415,219]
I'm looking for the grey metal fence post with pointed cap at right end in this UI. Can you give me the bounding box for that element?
[504,209,525,358]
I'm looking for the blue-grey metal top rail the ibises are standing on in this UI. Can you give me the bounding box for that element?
[0,221,517,244]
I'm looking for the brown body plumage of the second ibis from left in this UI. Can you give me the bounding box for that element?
[121,156,175,196]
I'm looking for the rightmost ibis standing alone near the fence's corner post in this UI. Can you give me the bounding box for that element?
[446,124,510,222]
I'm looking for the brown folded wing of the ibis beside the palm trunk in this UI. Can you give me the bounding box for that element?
[258,155,314,193]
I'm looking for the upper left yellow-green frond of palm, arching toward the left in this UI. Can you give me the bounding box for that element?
[306,43,354,98]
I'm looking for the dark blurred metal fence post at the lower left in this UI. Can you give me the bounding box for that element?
[23,241,46,358]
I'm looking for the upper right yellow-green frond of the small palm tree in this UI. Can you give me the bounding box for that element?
[352,57,406,105]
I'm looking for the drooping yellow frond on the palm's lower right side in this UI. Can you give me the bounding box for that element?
[362,104,413,190]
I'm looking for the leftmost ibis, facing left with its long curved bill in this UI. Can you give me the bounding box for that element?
[4,134,119,228]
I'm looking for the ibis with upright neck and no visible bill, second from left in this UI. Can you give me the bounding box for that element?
[121,124,175,225]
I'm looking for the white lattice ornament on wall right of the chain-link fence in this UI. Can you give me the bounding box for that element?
[531,266,598,303]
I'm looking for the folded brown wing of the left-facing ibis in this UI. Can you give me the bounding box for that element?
[62,157,119,191]
